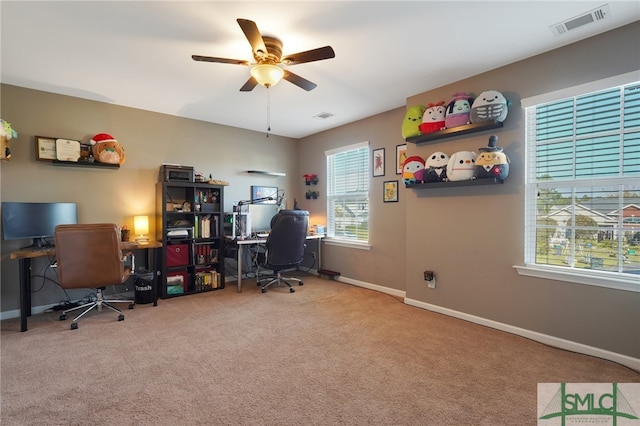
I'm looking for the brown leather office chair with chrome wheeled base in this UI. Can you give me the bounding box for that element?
[55,223,134,330]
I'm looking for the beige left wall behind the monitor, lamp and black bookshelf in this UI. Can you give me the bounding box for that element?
[0,85,302,313]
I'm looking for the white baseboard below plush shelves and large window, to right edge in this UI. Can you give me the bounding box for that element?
[404,298,640,372]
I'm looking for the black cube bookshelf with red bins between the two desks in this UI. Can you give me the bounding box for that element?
[156,182,225,299]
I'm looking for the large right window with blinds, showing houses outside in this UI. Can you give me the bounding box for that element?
[521,76,640,291]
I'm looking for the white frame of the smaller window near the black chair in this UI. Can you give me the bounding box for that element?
[323,141,371,250]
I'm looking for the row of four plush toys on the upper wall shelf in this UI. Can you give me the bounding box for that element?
[402,90,510,139]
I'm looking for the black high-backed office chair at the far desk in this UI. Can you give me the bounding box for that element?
[258,210,309,293]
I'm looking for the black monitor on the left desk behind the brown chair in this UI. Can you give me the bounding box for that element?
[2,202,78,248]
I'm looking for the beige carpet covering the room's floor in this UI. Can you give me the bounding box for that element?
[0,277,640,426]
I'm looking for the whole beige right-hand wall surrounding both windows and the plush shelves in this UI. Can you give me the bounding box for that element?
[300,22,640,358]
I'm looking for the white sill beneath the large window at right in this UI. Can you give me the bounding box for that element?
[513,265,640,293]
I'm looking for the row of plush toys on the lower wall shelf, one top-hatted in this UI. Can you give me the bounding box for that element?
[402,135,509,184]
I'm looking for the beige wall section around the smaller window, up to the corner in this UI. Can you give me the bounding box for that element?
[299,109,406,291]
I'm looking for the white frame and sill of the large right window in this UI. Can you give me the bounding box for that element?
[514,70,640,292]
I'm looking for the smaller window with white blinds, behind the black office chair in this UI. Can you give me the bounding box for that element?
[325,142,369,244]
